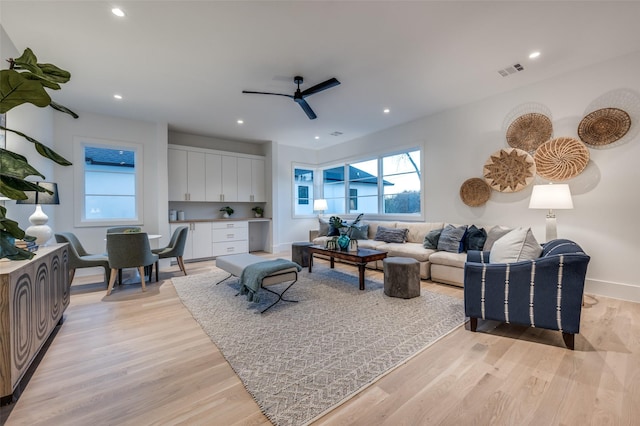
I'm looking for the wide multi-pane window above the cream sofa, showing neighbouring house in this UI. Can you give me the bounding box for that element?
[322,149,422,215]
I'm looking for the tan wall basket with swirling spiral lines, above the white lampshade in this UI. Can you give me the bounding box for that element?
[534,137,589,182]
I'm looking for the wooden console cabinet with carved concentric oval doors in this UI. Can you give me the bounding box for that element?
[0,244,69,403]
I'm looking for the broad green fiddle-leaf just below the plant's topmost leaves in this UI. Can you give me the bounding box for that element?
[0,70,51,114]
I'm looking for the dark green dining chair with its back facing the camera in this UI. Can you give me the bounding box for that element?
[107,232,158,296]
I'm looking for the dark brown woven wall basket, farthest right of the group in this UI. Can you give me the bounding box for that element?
[578,108,631,146]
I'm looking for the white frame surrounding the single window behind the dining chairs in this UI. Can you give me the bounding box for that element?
[73,137,144,227]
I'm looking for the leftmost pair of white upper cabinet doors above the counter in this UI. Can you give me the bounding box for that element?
[167,148,206,201]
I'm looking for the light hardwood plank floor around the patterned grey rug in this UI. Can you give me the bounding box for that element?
[0,255,640,426]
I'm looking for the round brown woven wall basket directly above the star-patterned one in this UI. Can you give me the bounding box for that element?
[507,112,553,152]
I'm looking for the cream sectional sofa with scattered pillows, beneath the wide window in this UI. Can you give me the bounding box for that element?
[309,220,500,287]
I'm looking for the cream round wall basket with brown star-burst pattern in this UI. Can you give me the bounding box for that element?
[482,148,536,192]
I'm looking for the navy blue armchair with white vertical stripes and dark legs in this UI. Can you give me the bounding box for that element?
[464,239,590,349]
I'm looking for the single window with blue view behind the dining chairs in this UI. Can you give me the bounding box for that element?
[75,141,142,226]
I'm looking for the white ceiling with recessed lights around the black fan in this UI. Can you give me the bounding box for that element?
[0,0,640,148]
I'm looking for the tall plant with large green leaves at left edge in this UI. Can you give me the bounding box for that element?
[0,48,78,260]
